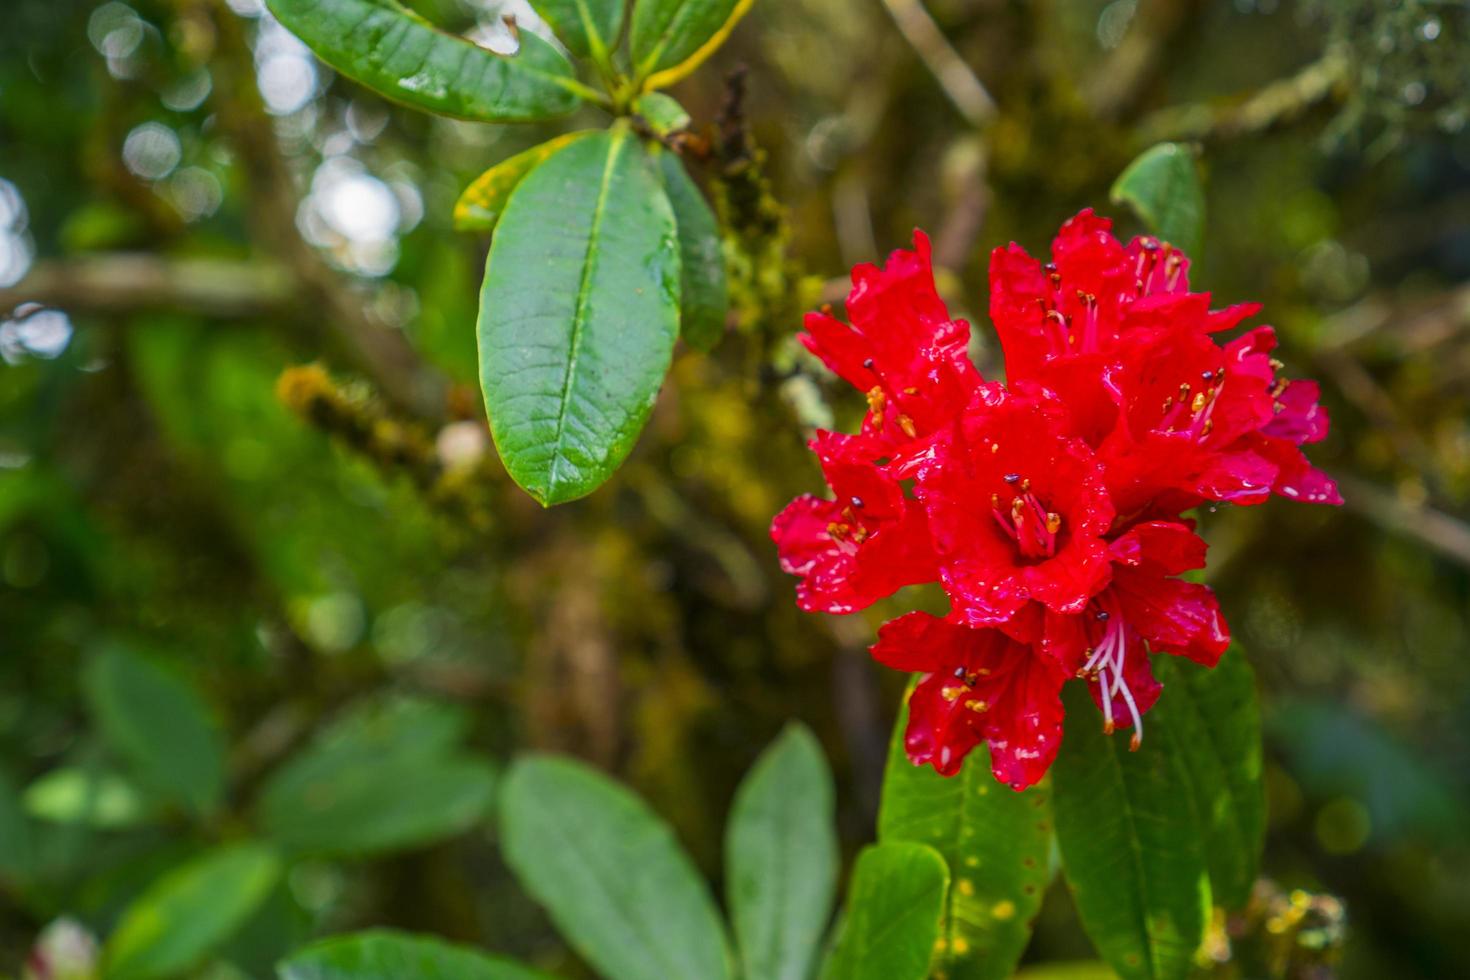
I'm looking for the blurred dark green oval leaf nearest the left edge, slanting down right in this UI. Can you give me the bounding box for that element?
[82,646,225,814]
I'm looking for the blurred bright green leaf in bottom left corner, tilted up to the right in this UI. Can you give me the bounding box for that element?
[103,843,281,980]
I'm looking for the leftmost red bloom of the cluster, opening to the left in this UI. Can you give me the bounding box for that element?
[770,432,938,613]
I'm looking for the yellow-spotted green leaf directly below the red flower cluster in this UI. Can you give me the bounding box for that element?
[878,688,1053,980]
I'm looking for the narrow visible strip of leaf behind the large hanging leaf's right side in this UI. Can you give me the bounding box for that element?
[657,151,729,351]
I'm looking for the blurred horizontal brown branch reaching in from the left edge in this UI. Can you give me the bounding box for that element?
[0,253,297,317]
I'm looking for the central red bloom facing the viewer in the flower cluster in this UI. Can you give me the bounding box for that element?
[916,383,1113,626]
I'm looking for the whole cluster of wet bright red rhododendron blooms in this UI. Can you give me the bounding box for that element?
[772,212,1341,789]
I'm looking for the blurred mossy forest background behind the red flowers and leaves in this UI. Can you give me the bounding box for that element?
[0,0,1470,977]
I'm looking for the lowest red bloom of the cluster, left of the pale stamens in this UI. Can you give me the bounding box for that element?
[873,613,1067,789]
